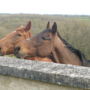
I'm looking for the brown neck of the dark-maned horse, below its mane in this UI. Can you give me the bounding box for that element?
[54,36,82,65]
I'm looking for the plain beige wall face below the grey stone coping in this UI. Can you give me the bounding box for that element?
[0,75,82,90]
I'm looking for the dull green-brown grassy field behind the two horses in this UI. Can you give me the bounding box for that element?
[0,14,90,59]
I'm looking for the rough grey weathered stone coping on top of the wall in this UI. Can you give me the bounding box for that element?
[0,57,90,89]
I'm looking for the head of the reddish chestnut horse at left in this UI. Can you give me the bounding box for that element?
[0,21,31,55]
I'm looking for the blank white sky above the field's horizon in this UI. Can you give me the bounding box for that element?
[0,0,90,15]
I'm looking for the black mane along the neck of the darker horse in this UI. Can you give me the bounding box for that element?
[57,32,87,64]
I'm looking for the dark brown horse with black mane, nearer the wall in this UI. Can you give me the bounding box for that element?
[14,23,89,66]
